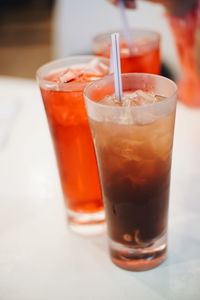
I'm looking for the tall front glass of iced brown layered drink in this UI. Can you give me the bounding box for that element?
[84,73,177,271]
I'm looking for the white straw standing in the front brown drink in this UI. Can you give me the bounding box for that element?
[111,33,122,101]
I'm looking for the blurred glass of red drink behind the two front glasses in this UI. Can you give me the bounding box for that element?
[93,29,160,74]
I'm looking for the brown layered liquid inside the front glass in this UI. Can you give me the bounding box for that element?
[92,115,174,247]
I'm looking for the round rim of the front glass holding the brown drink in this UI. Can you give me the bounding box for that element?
[83,73,178,110]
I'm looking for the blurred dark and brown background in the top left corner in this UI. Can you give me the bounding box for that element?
[0,0,54,78]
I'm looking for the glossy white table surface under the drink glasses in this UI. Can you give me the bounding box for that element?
[0,77,200,300]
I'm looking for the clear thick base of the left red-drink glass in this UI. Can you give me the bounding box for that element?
[67,209,105,236]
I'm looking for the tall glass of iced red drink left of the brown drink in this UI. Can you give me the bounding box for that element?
[37,56,109,234]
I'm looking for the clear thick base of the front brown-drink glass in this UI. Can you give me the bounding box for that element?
[109,234,167,271]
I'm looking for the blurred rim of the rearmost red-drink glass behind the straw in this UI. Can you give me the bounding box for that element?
[92,28,161,48]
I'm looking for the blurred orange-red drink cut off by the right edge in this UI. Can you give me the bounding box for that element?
[168,10,200,107]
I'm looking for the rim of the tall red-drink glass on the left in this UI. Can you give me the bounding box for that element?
[36,54,110,87]
